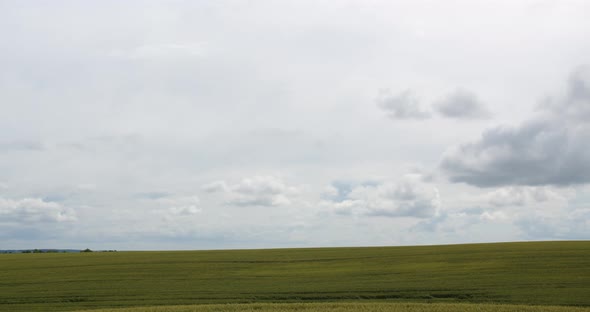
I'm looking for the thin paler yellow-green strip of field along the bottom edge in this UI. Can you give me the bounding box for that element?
[75,302,590,312]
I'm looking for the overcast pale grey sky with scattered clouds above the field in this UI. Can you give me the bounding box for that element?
[0,0,590,250]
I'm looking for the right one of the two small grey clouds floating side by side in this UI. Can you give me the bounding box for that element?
[433,90,492,119]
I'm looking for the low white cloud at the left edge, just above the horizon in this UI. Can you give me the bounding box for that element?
[0,198,76,224]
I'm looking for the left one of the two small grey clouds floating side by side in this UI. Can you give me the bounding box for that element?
[377,90,430,119]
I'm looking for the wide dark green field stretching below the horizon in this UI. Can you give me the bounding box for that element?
[0,241,590,311]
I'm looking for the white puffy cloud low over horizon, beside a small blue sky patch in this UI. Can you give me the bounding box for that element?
[323,175,440,218]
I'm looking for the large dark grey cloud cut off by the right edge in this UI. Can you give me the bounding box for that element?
[441,67,590,187]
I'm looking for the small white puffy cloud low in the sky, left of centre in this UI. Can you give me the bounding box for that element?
[203,176,299,206]
